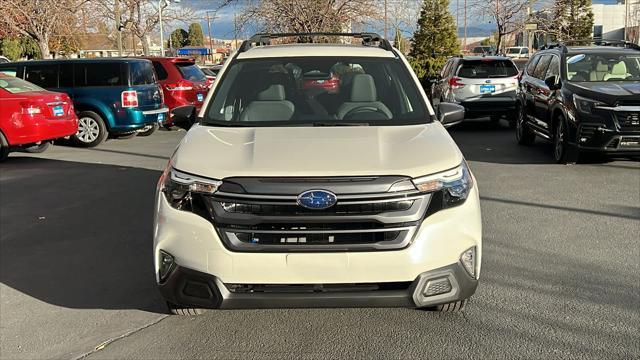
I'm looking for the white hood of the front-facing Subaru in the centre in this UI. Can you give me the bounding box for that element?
[171,123,463,179]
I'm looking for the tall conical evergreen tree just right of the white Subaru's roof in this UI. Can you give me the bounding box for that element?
[409,0,460,80]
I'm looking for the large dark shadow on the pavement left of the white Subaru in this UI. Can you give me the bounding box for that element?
[0,157,165,312]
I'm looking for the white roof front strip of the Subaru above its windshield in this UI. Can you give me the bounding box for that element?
[238,44,395,59]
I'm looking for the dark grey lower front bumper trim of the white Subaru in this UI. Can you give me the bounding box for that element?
[158,263,478,309]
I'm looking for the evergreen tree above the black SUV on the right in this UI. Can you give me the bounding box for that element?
[550,0,593,41]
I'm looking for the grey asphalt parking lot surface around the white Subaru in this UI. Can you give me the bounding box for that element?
[0,121,640,359]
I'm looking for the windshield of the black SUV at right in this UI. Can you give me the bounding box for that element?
[567,53,640,82]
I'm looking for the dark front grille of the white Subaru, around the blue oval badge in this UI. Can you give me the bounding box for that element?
[194,177,431,252]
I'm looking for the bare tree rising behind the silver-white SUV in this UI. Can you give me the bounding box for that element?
[472,0,532,51]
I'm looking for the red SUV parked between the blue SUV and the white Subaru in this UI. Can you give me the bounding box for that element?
[145,57,210,125]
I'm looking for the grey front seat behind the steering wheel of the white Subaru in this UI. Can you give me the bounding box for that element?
[336,74,393,119]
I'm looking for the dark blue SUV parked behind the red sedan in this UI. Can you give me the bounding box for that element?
[0,59,168,147]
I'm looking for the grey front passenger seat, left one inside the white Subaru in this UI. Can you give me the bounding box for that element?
[240,84,295,121]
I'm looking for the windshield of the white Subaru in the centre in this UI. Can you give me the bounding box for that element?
[203,57,430,127]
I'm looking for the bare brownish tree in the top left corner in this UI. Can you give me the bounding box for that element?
[0,0,89,58]
